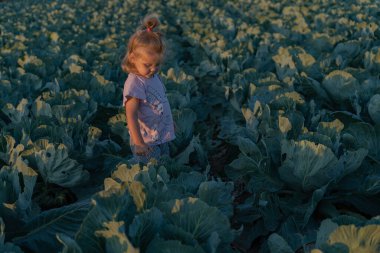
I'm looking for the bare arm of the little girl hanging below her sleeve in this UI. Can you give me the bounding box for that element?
[125,97,149,155]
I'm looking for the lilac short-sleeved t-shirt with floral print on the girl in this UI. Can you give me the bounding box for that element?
[123,73,175,145]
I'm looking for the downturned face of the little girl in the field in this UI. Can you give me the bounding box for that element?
[131,48,160,78]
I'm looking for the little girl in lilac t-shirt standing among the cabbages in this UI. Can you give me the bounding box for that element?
[122,16,175,163]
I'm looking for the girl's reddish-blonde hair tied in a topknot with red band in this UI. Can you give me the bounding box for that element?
[121,14,165,73]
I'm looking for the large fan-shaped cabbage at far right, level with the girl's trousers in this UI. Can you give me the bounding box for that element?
[279,140,368,192]
